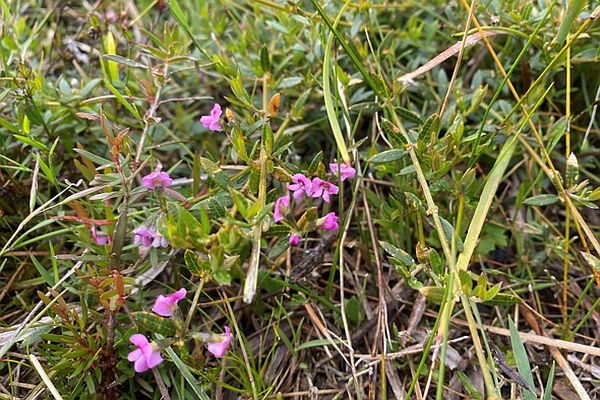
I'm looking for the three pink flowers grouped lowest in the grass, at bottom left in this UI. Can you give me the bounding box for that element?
[127,288,231,373]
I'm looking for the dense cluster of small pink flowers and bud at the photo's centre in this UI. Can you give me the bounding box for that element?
[273,163,356,246]
